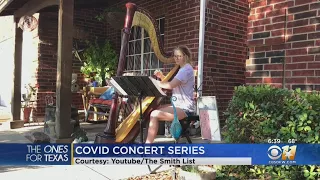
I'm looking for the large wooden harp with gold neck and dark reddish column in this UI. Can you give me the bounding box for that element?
[95,3,179,143]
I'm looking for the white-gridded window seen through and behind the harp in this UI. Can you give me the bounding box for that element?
[125,17,164,76]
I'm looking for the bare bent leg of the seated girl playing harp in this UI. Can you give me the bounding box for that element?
[146,106,187,144]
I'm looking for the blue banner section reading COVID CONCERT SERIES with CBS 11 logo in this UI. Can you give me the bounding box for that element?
[74,144,320,165]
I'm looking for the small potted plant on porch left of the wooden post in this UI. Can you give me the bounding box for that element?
[22,83,36,123]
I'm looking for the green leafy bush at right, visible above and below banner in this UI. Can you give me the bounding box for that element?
[217,85,320,179]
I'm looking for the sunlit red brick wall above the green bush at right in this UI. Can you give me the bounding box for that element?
[246,0,320,90]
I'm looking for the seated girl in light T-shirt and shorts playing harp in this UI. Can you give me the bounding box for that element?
[146,46,195,143]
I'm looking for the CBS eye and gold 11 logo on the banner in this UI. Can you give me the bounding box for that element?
[268,145,297,161]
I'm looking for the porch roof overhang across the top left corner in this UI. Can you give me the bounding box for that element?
[0,0,118,16]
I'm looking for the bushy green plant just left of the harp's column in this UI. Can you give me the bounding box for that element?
[81,40,118,85]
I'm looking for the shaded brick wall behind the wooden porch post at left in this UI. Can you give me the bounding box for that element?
[37,9,107,117]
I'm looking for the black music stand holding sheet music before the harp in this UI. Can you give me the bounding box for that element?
[110,76,166,143]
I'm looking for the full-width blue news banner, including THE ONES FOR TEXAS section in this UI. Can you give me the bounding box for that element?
[0,144,320,165]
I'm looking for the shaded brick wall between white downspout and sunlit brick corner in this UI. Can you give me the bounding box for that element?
[203,0,249,119]
